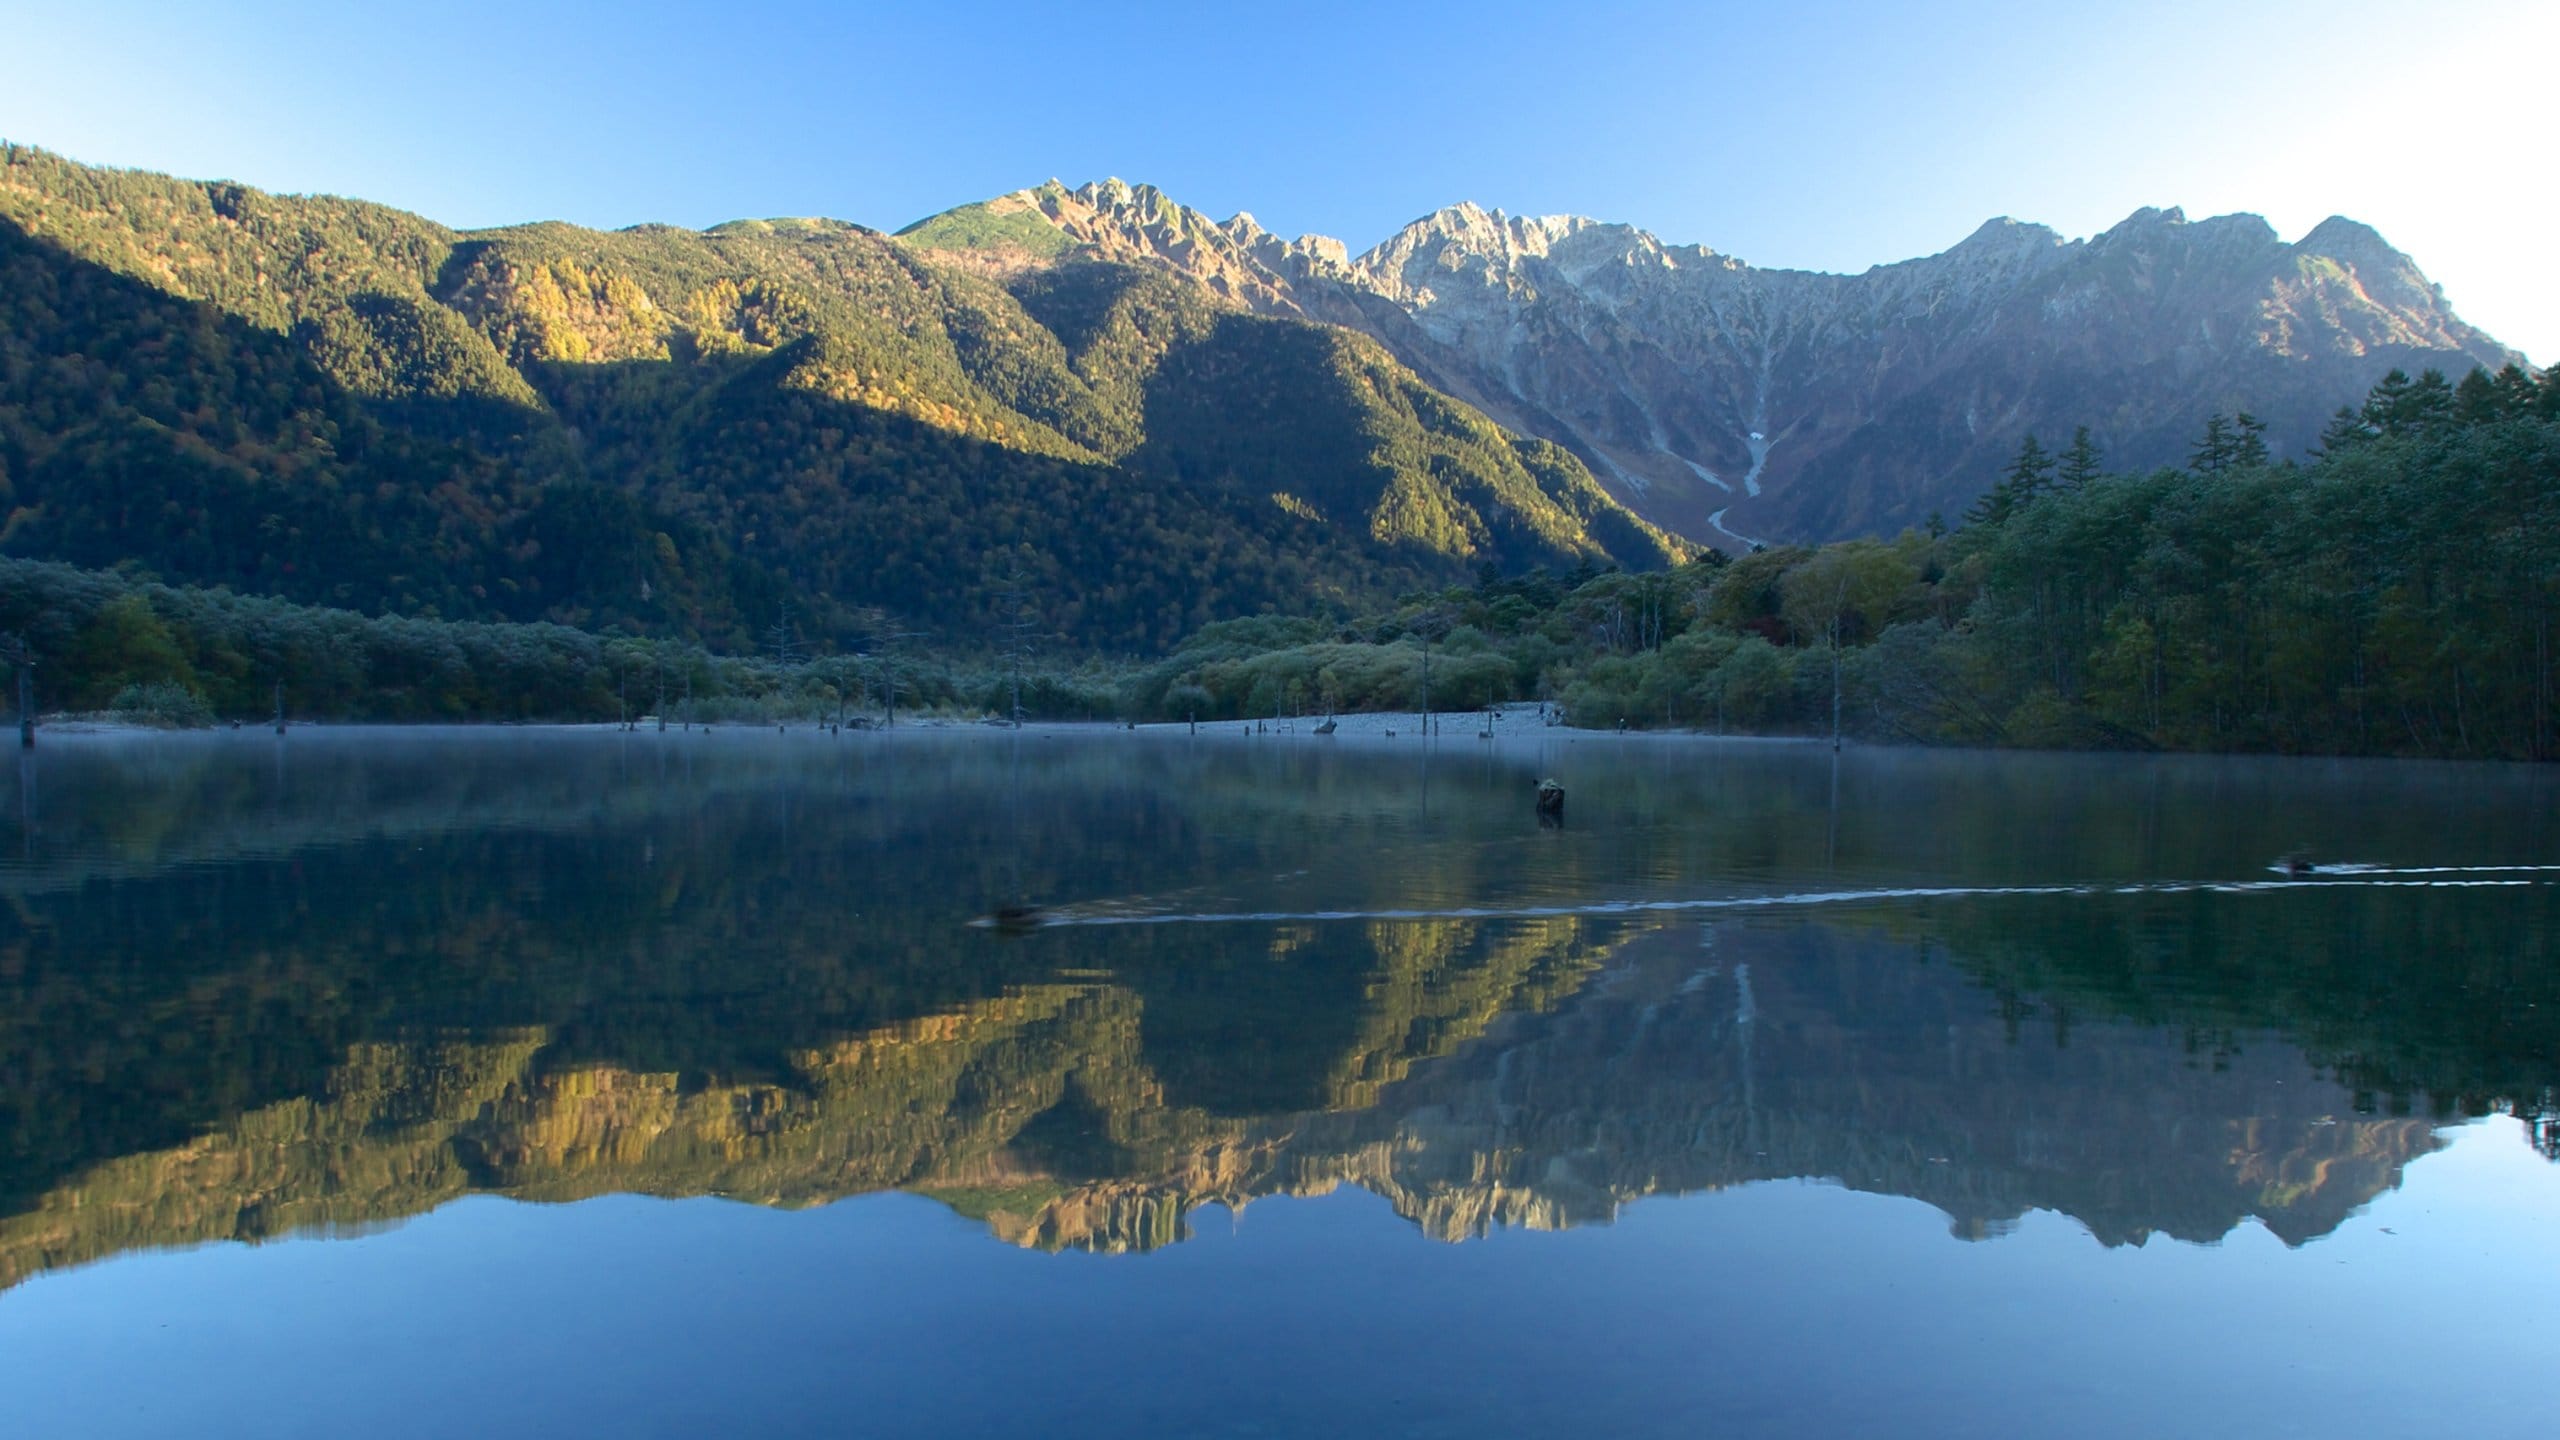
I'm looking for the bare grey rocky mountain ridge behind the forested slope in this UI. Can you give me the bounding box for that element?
[919,179,2522,548]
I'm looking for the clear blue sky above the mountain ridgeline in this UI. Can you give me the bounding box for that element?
[0,0,2560,361]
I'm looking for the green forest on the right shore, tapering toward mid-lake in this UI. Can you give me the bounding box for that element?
[1134,366,2560,761]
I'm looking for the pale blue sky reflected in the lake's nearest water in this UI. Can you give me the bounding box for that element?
[0,1120,2560,1437]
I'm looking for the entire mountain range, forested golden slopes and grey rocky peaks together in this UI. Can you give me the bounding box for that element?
[0,146,2519,648]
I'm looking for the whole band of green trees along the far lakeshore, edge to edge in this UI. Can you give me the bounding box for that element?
[0,358,2560,758]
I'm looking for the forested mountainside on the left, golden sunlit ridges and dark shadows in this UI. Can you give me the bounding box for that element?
[0,146,1679,651]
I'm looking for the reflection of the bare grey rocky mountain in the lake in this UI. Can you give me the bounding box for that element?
[1280,925,2435,1243]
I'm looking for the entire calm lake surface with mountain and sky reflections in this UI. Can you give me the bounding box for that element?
[0,730,2560,1437]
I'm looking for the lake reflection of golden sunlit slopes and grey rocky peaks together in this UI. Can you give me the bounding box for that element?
[0,907,2435,1281]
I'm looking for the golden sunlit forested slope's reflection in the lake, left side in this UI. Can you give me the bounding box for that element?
[0,907,1595,1279]
